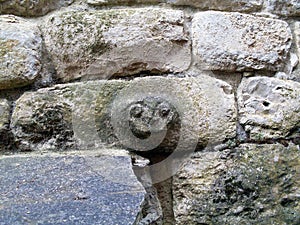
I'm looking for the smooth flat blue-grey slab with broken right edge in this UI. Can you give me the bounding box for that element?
[0,149,146,225]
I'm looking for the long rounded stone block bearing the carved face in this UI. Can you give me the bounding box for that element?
[12,74,236,151]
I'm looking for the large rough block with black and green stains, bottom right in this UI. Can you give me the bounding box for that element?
[173,144,300,225]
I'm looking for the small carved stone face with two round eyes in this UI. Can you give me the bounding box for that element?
[129,97,178,139]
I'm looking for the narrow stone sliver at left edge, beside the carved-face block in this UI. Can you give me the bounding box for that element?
[0,99,10,151]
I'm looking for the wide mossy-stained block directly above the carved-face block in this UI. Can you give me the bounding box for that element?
[41,8,191,81]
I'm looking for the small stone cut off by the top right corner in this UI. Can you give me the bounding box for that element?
[265,0,300,16]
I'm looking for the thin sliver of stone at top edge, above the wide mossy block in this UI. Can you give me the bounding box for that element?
[87,0,165,6]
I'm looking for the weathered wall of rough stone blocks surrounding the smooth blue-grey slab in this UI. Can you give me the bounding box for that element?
[0,0,300,225]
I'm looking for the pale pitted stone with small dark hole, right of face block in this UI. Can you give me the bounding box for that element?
[238,77,300,141]
